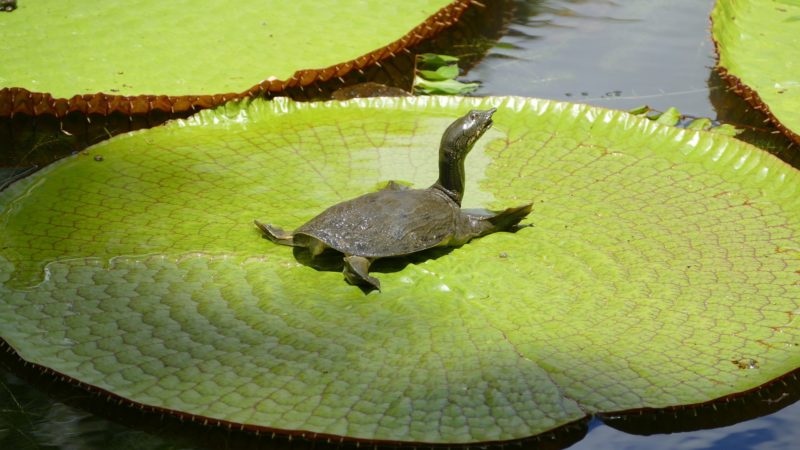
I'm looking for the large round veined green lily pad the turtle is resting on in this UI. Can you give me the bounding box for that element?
[0,97,800,443]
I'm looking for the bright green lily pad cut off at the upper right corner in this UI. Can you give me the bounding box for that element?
[711,0,800,143]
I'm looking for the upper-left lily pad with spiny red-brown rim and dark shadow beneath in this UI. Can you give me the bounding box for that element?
[0,0,494,168]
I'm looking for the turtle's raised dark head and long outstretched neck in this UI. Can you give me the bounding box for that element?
[431,108,497,206]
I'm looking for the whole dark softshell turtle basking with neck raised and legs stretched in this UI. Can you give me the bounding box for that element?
[255,108,531,290]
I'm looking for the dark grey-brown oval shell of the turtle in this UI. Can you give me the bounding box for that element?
[294,188,464,258]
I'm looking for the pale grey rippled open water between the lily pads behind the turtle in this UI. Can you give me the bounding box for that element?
[468,0,724,117]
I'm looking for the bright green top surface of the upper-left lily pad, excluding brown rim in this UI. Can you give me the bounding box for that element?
[0,0,450,98]
